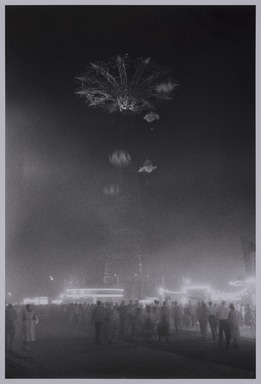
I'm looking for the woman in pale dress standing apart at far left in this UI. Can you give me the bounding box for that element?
[22,304,39,352]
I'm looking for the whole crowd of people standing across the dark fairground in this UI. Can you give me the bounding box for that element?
[5,300,255,351]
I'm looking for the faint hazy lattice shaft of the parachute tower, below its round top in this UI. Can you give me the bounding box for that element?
[104,158,145,299]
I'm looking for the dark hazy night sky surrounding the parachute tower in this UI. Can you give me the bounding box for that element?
[6,5,255,298]
